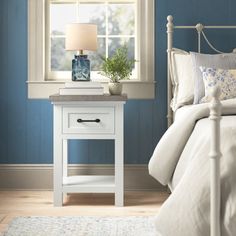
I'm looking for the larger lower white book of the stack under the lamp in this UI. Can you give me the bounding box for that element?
[59,87,104,95]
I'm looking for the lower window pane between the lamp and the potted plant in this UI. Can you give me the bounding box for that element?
[86,38,106,71]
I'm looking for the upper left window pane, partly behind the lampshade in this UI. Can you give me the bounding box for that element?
[50,4,76,35]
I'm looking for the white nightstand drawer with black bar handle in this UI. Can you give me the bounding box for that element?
[63,106,114,134]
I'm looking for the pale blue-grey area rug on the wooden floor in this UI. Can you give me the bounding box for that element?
[2,216,156,236]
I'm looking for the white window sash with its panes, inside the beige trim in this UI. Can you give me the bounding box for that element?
[46,0,138,79]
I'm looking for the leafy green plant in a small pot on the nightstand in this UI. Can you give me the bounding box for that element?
[101,46,135,95]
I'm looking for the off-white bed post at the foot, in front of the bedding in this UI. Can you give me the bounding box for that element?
[209,88,221,236]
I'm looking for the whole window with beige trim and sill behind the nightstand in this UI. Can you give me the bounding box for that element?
[28,0,154,98]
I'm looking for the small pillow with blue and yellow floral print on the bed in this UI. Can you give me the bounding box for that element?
[200,66,236,103]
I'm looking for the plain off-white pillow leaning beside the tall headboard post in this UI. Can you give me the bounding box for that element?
[170,49,194,111]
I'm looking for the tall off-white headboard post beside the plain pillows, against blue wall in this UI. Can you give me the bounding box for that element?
[166,15,174,127]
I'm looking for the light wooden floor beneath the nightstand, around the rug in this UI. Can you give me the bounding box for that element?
[0,191,169,232]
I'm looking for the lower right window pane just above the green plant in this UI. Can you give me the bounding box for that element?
[108,38,135,62]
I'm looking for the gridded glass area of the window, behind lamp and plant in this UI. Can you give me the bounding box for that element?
[50,1,135,75]
